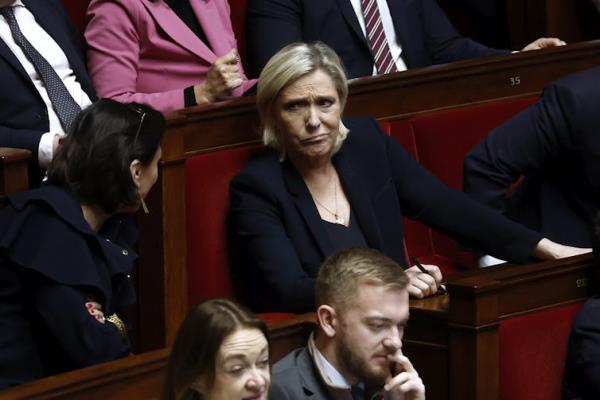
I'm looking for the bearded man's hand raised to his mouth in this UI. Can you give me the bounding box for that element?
[383,339,425,400]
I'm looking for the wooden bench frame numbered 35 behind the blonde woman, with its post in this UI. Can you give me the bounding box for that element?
[139,41,600,350]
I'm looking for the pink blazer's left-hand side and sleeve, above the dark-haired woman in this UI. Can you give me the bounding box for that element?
[85,0,254,112]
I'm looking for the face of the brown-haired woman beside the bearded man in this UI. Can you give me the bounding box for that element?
[203,328,271,400]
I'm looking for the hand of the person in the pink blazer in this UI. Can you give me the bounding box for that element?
[194,49,242,104]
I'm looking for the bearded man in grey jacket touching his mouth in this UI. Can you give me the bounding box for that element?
[270,248,425,400]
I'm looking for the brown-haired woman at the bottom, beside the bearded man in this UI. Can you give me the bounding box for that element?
[163,299,271,400]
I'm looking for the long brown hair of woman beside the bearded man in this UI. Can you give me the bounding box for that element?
[163,299,269,400]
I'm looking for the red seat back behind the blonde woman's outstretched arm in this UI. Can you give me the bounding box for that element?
[391,98,535,275]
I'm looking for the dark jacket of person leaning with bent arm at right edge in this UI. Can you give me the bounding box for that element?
[464,68,600,247]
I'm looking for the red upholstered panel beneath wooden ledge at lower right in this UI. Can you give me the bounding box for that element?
[500,303,582,400]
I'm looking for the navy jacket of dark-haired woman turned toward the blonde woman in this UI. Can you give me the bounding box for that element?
[0,186,137,387]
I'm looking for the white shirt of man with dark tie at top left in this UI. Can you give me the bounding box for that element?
[0,0,92,168]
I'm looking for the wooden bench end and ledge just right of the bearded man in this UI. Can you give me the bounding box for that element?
[403,255,594,400]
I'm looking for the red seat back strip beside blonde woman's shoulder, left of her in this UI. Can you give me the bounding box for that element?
[185,145,260,305]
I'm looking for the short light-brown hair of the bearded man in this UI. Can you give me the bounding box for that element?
[316,247,408,309]
